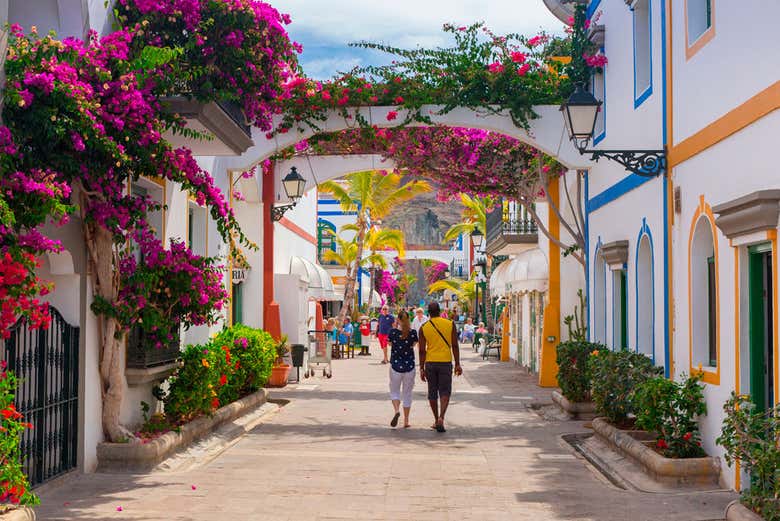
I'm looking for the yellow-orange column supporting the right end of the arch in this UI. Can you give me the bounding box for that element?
[539,178,561,387]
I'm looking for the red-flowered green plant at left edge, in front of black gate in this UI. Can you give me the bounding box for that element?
[0,368,39,506]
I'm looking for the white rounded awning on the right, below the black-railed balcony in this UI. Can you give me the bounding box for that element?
[490,248,550,296]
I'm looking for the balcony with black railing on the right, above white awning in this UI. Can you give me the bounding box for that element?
[485,201,539,255]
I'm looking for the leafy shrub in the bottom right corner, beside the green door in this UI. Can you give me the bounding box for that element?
[715,392,780,521]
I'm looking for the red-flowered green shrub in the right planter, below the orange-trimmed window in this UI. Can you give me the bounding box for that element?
[631,373,707,458]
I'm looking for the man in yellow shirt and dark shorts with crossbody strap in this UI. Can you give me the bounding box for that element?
[420,302,463,432]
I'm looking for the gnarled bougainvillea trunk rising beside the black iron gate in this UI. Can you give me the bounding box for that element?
[81,193,132,442]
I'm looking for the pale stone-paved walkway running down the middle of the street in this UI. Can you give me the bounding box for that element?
[37,349,733,521]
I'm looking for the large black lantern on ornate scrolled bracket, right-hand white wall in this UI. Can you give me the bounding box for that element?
[561,83,666,177]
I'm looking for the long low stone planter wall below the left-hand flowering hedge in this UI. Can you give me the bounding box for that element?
[97,389,268,472]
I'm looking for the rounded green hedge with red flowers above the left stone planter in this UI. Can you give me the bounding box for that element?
[163,324,278,423]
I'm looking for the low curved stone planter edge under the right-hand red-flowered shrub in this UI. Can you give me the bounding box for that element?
[592,418,720,485]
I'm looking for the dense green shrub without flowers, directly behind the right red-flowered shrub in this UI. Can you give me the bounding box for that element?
[588,350,663,426]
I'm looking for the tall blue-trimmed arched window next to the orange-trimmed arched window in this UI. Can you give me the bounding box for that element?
[636,232,655,358]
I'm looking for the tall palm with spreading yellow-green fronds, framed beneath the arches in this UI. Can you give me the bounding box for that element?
[319,170,431,321]
